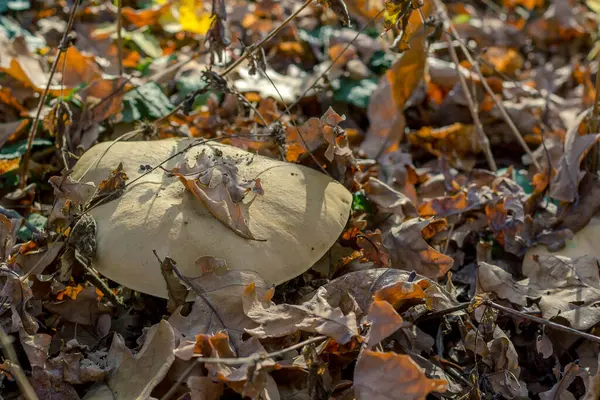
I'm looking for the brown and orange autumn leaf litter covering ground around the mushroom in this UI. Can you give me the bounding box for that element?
[0,0,600,400]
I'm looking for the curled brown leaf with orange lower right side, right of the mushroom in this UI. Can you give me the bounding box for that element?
[383,218,454,279]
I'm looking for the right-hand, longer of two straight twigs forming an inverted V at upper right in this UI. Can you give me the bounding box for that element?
[434,0,542,172]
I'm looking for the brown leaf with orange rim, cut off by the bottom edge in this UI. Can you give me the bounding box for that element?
[354,350,447,400]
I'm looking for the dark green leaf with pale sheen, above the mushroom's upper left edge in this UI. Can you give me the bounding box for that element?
[123,82,175,122]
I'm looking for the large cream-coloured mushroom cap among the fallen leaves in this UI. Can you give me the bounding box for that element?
[72,139,352,298]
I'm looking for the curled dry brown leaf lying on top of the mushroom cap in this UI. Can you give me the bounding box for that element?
[171,150,264,239]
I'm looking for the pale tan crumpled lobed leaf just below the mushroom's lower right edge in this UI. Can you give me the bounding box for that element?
[243,284,358,344]
